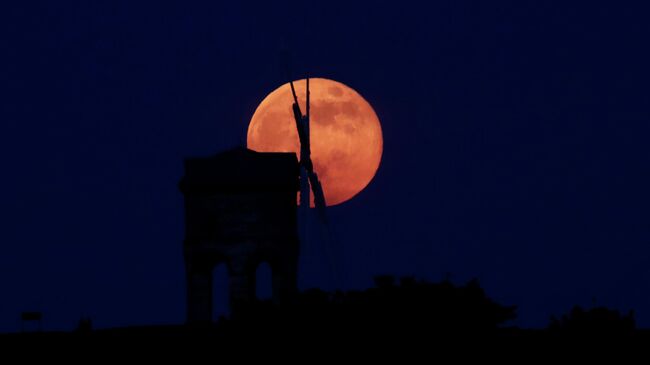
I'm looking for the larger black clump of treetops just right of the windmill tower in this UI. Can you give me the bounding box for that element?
[221,276,516,334]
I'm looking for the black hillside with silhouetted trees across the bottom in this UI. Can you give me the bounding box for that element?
[0,277,650,359]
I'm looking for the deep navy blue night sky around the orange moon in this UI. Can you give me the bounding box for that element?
[0,0,650,332]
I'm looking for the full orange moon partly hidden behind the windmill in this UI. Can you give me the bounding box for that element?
[247,78,383,207]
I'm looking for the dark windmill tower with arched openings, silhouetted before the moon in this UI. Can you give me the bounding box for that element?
[179,148,300,323]
